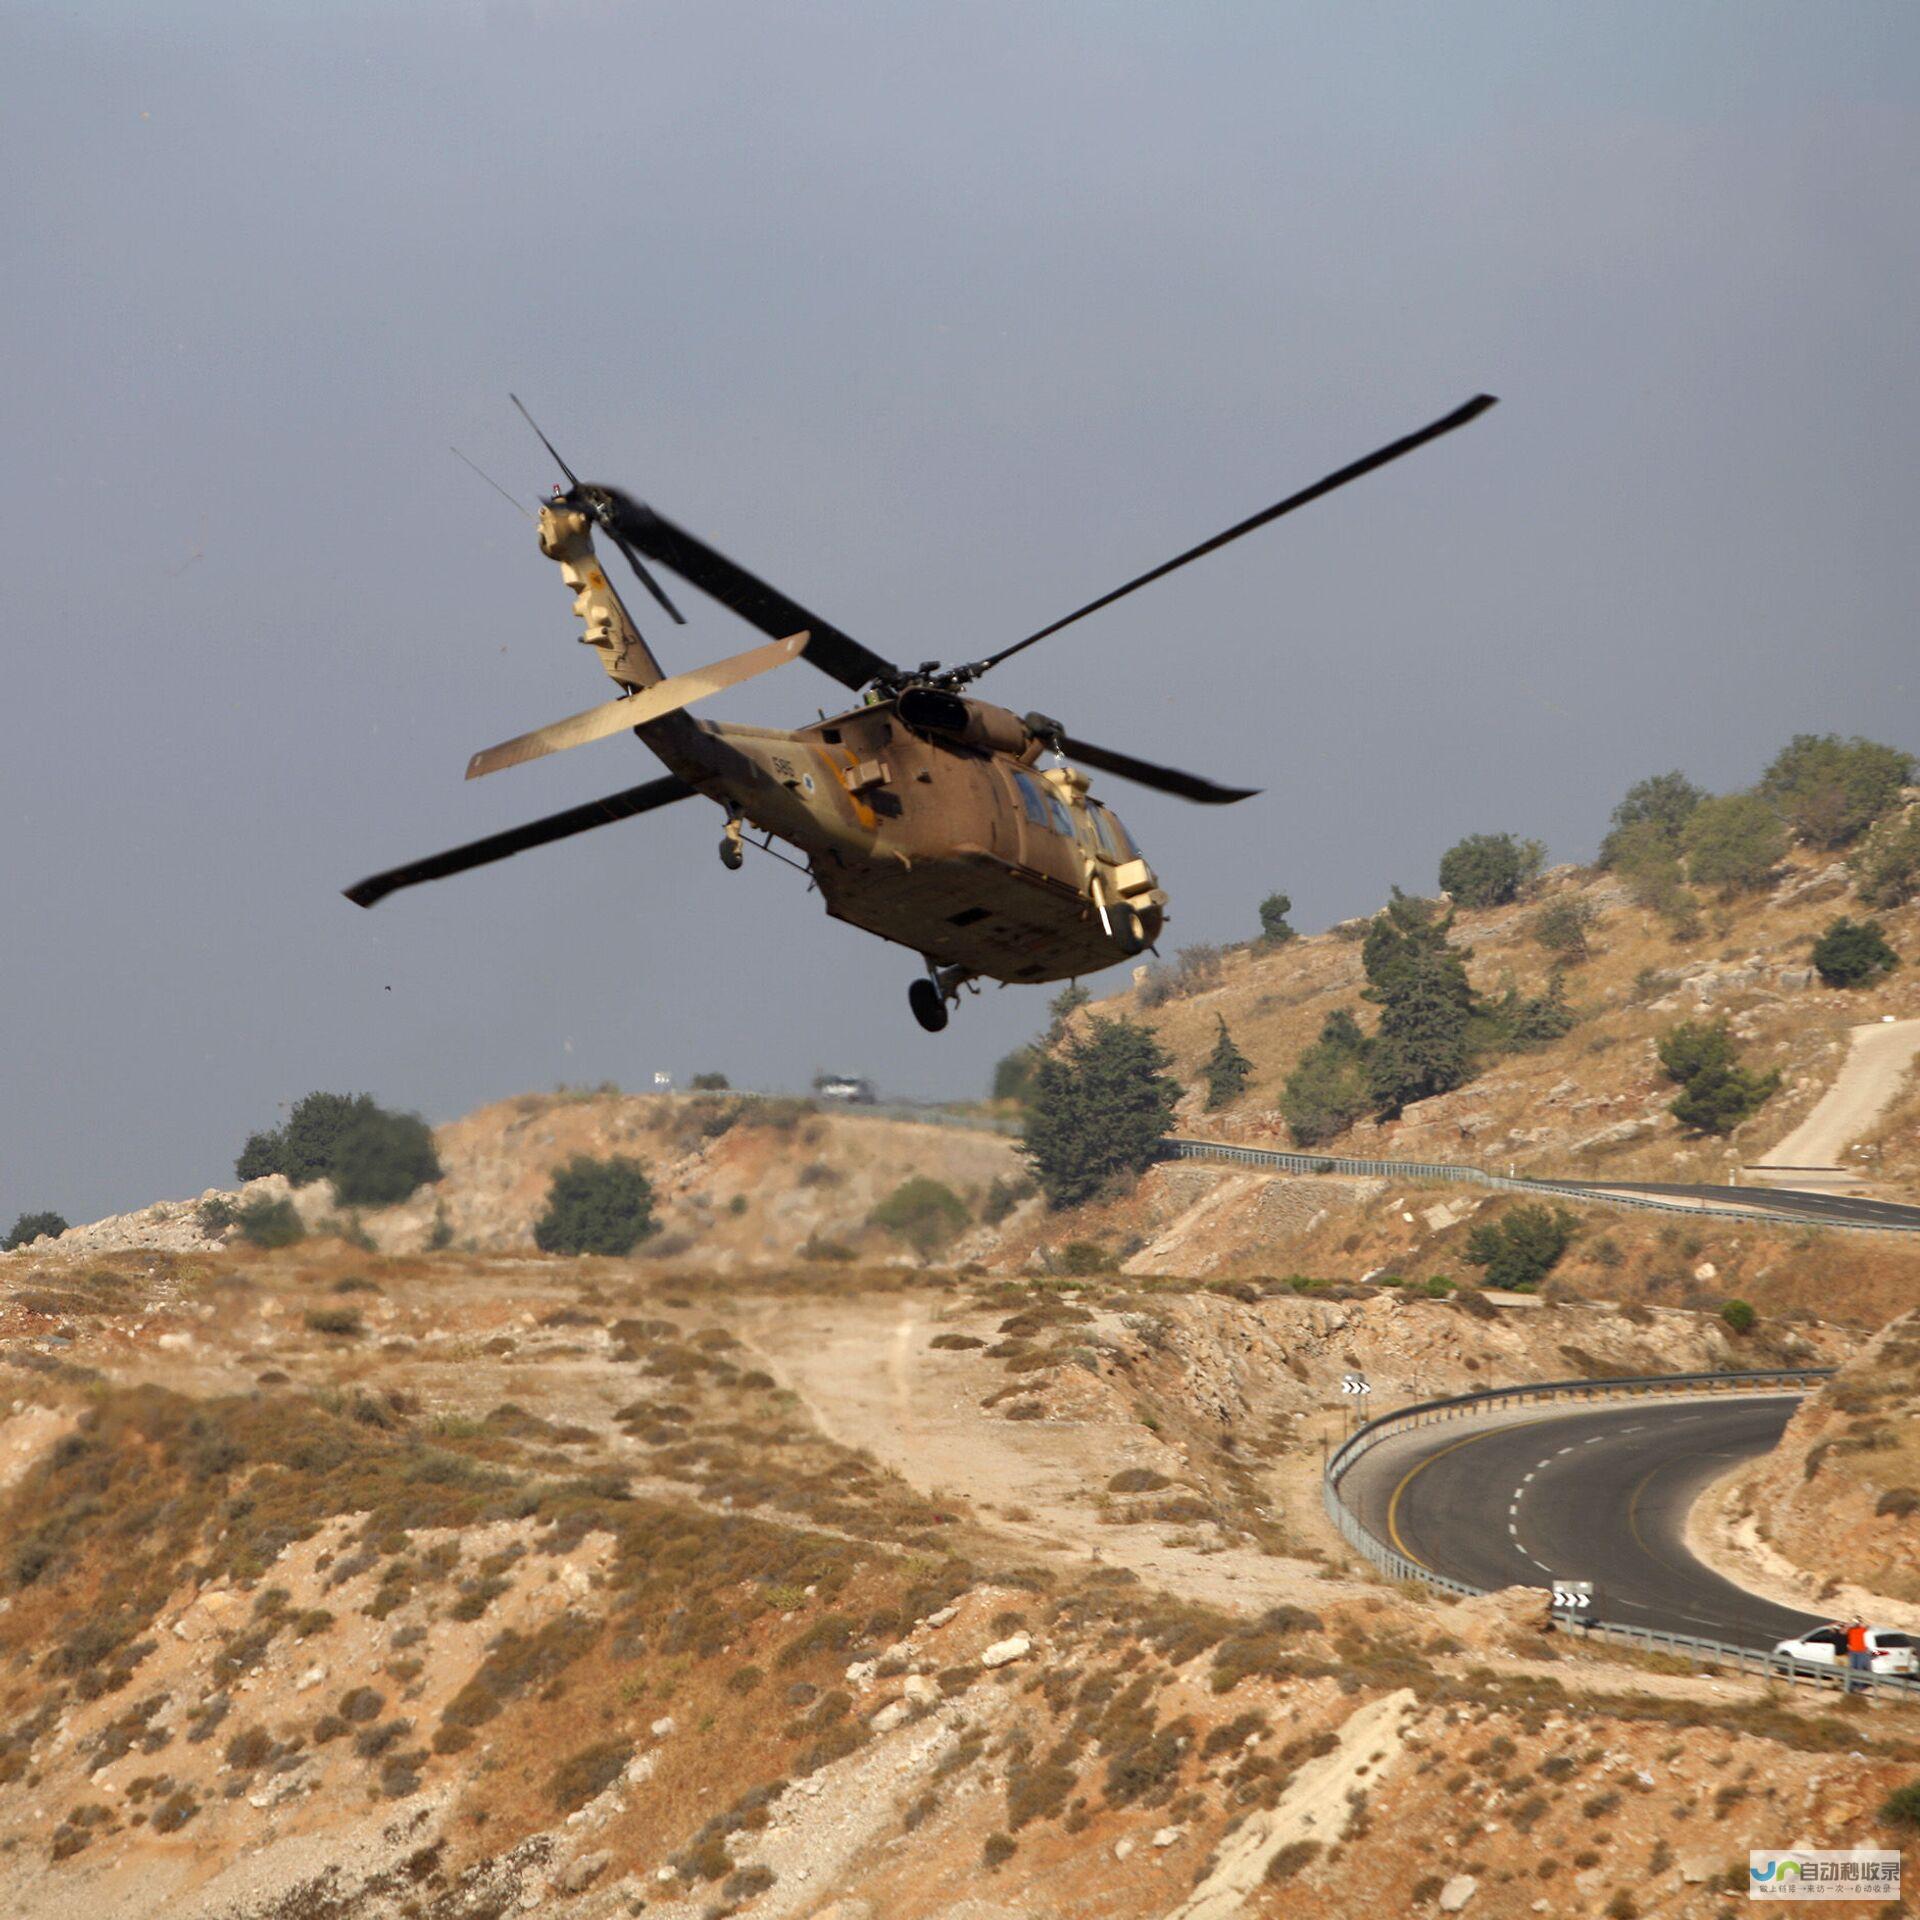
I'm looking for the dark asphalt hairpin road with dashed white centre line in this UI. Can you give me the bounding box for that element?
[1340,1394,1818,1647]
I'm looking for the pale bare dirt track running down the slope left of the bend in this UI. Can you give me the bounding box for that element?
[733,1296,1373,1613]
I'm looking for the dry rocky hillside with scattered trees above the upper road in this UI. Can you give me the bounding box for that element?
[1091,854,1920,1198]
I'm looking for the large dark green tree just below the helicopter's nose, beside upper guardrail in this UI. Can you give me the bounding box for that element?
[1020,1016,1179,1208]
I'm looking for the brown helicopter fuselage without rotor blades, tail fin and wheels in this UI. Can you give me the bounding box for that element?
[636,699,1167,983]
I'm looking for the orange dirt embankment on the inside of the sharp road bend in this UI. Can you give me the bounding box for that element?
[1699,1313,1920,1628]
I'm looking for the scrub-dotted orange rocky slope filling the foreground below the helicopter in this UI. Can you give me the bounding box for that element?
[0,1240,1920,1920]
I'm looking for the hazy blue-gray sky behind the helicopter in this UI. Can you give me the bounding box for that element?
[0,0,1920,1223]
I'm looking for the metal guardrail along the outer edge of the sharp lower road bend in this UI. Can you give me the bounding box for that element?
[1321,1367,1920,1699]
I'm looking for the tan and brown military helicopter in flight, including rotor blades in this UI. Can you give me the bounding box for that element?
[346,394,1494,1033]
